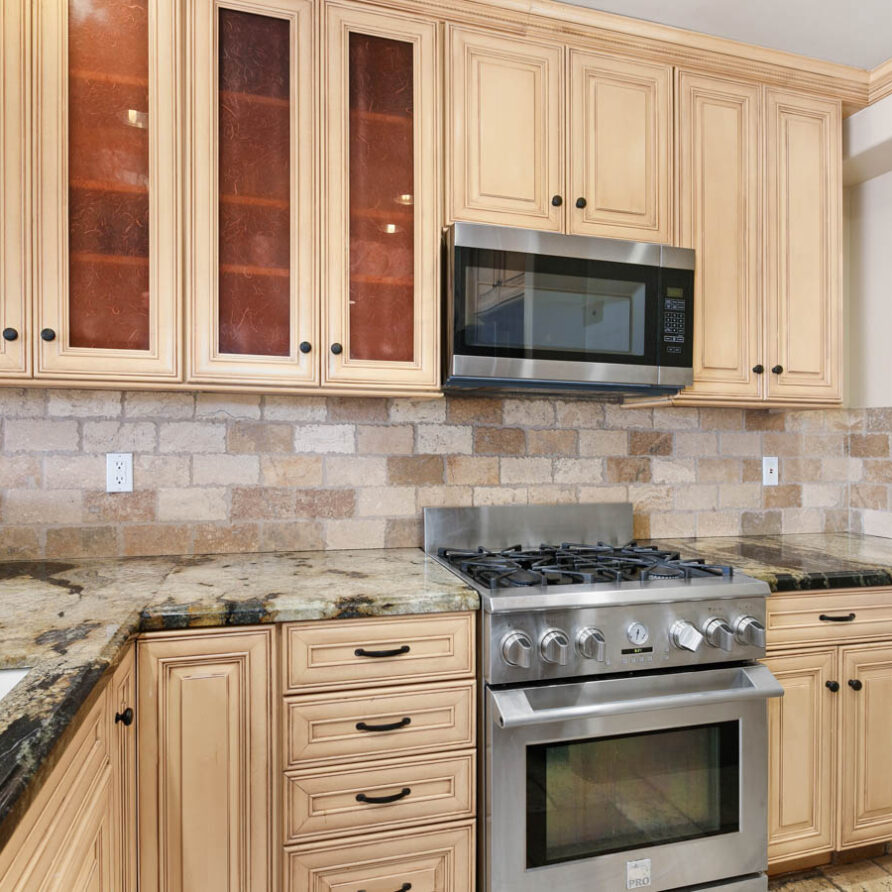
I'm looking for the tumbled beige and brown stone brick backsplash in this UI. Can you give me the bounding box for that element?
[0,389,880,558]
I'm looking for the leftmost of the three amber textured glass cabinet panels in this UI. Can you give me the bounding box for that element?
[68,0,149,350]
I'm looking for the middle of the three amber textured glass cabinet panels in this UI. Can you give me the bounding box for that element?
[218,9,291,356]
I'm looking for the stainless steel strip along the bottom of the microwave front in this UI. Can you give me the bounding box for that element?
[447,353,694,387]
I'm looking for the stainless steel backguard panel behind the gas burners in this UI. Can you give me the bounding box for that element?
[424,502,632,554]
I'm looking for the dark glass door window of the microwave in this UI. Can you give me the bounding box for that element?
[455,248,659,365]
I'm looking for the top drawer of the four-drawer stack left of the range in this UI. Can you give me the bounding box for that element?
[283,613,474,694]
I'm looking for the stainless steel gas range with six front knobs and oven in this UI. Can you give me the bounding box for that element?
[424,504,782,892]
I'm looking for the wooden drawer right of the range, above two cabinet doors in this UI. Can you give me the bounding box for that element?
[766,588,892,648]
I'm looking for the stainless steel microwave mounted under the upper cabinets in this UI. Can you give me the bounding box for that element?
[443,223,694,395]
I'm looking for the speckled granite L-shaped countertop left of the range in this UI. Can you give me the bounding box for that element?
[0,548,479,845]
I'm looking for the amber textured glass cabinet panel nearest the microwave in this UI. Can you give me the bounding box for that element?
[349,33,415,362]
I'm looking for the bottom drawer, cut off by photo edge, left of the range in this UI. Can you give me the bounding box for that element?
[285,822,474,892]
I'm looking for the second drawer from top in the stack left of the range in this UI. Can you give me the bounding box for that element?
[285,681,475,768]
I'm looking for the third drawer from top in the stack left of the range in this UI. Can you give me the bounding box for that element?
[285,750,475,843]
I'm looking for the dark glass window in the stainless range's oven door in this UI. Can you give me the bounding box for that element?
[527,721,740,867]
